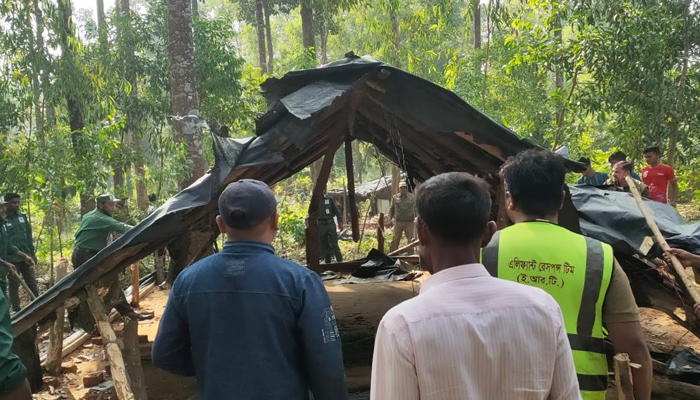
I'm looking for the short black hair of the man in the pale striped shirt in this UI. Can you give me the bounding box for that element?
[416,172,491,244]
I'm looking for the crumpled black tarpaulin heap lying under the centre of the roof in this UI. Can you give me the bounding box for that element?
[334,249,422,285]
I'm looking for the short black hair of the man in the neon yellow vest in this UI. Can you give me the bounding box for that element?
[501,149,566,217]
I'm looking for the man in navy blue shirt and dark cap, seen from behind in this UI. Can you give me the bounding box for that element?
[153,179,347,400]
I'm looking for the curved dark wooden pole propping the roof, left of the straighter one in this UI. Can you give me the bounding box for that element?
[306,142,342,273]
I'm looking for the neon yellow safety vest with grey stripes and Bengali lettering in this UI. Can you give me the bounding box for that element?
[482,222,613,400]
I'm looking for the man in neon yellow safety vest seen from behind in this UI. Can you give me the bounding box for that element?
[482,150,652,400]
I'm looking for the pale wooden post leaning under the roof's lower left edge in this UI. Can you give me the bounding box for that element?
[85,285,135,400]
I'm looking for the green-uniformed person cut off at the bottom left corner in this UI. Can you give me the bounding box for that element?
[0,290,32,400]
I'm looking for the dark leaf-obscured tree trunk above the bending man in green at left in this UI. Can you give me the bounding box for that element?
[58,0,95,215]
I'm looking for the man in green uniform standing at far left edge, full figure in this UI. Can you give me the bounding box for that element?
[5,193,39,312]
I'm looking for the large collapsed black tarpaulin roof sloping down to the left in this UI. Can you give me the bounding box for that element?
[12,55,581,334]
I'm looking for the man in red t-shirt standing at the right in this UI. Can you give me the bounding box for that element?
[642,146,678,207]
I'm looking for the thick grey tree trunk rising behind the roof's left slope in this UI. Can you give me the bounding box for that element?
[166,0,206,188]
